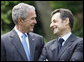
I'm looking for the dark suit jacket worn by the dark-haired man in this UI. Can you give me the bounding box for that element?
[39,34,83,61]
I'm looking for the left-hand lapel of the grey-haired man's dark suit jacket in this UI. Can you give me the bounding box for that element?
[11,30,27,60]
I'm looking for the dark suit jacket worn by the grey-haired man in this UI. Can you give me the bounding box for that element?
[1,29,44,61]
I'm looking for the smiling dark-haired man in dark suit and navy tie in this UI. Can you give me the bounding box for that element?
[39,8,83,61]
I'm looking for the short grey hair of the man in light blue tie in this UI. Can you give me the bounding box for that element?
[12,3,35,24]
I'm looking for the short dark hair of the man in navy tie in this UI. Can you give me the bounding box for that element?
[51,8,74,29]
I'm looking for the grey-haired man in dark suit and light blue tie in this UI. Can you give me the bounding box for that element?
[1,3,44,61]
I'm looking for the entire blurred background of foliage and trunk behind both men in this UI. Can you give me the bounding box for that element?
[1,1,83,42]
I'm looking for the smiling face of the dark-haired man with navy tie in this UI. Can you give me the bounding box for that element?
[50,13,65,35]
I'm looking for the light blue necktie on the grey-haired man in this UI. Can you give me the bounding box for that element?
[22,34,30,61]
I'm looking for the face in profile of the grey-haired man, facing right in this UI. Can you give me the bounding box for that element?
[23,10,37,33]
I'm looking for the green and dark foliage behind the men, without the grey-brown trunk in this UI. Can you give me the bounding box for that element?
[1,1,83,40]
